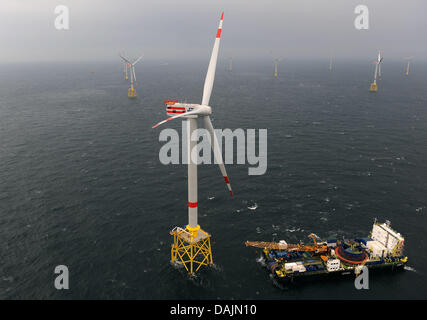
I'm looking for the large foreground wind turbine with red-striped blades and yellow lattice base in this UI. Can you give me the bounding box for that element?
[153,12,233,274]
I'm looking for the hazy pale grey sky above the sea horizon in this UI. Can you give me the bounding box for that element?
[0,0,427,63]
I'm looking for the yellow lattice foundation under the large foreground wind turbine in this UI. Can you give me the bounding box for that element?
[170,226,213,274]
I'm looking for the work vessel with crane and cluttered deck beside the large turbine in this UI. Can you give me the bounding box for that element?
[246,221,408,282]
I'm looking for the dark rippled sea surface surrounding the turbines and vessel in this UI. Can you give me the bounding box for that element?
[0,55,427,299]
